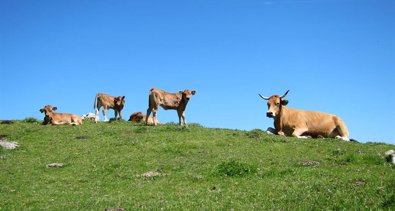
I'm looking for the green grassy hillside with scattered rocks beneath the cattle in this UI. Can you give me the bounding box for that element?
[0,121,395,210]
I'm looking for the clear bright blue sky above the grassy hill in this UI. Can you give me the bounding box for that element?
[0,0,395,144]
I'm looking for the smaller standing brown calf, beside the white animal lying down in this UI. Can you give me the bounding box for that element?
[93,93,125,123]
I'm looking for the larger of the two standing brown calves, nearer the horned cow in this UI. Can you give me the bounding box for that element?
[145,88,196,127]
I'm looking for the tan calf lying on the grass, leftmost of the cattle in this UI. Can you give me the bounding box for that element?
[40,105,82,125]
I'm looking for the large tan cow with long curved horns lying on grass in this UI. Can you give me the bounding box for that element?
[259,90,350,141]
